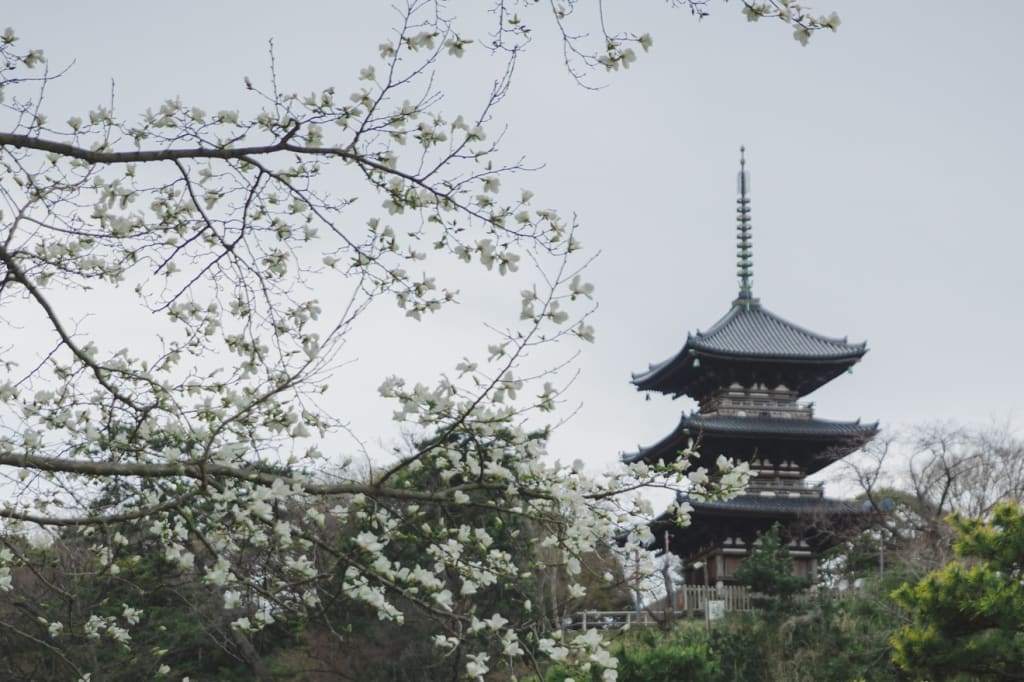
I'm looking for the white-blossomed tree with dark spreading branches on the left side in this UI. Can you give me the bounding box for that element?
[0,0,798,680]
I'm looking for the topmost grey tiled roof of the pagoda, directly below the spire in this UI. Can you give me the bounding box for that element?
[633,298,867,398]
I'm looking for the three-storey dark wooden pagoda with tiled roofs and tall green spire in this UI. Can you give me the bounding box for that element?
[623,147,878,584]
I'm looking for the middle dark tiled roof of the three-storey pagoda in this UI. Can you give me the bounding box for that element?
[622,414,879,473]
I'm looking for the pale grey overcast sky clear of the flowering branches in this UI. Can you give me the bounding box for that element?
[8,0,1024,489]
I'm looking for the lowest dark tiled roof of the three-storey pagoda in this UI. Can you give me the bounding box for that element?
[650,494,866,556]
